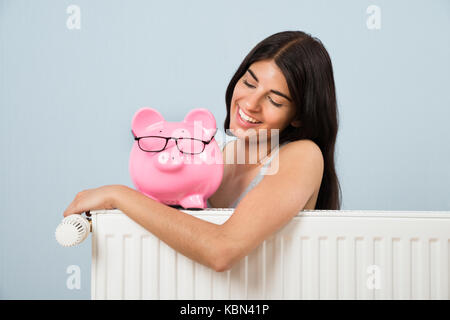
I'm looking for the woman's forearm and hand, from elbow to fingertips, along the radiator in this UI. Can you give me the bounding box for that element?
[63,185,226,271]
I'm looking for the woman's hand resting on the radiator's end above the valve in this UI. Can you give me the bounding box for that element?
[64,185,124,217]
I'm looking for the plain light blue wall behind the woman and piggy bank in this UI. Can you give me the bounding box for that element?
[0,0,450,299]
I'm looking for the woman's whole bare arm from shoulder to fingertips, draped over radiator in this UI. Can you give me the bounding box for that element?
[64,140,323,272]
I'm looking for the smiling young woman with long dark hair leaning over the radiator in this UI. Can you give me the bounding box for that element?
[64,31,340,271]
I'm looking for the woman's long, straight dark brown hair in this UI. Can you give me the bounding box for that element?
[224,31,342,210]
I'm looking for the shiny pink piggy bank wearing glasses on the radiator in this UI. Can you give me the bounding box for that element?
[129,108,223,209]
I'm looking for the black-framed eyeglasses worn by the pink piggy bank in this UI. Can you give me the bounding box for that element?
[131,128,217,154]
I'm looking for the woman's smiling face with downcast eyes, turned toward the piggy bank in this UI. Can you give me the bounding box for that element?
[230,60,299,142]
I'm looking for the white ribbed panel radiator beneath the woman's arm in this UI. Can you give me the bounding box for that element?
[91,209,450,299]
